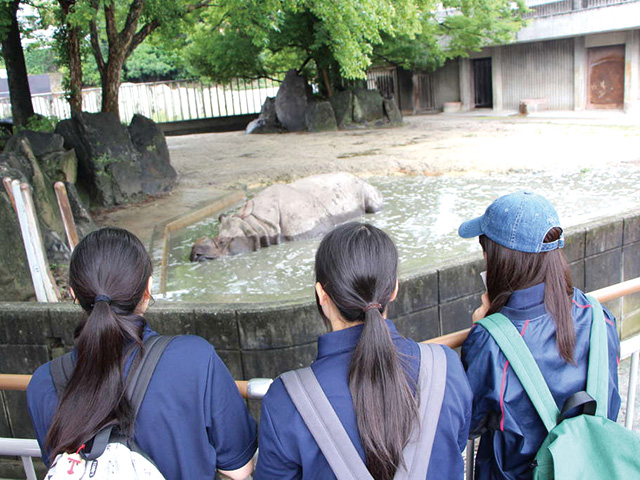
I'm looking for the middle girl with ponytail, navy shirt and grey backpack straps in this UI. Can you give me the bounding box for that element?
[255,222,471,480]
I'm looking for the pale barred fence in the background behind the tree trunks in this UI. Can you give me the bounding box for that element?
[0,79,280,122]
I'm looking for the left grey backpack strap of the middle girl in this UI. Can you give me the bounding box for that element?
[280,367,373,480]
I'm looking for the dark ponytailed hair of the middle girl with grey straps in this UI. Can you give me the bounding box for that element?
[316,222,417,480]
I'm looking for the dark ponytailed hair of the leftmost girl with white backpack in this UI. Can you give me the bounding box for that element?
[46,228,152,459]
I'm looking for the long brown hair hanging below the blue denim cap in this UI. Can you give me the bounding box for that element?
[480,227,576,363]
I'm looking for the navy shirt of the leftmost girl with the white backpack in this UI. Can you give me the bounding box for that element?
[27,326,257,480]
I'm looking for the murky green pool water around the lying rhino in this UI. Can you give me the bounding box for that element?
[159,167,640,302]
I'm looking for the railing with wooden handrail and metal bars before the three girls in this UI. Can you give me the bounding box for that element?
[0,277,640,480]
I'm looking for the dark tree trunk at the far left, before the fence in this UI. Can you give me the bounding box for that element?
[0,1,34,126]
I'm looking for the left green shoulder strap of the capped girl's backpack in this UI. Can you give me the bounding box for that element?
[478,313,560,431]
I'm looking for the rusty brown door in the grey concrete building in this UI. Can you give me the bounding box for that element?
[587,45,624,108]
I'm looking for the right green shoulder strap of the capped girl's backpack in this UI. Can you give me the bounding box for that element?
[587,295,609,418]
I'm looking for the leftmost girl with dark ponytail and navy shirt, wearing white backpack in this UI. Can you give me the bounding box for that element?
[27,228,256,479]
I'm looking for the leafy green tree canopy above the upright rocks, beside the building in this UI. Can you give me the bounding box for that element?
[186,0,526,95]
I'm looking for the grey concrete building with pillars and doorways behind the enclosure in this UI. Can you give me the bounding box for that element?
[370,0,640,113]
